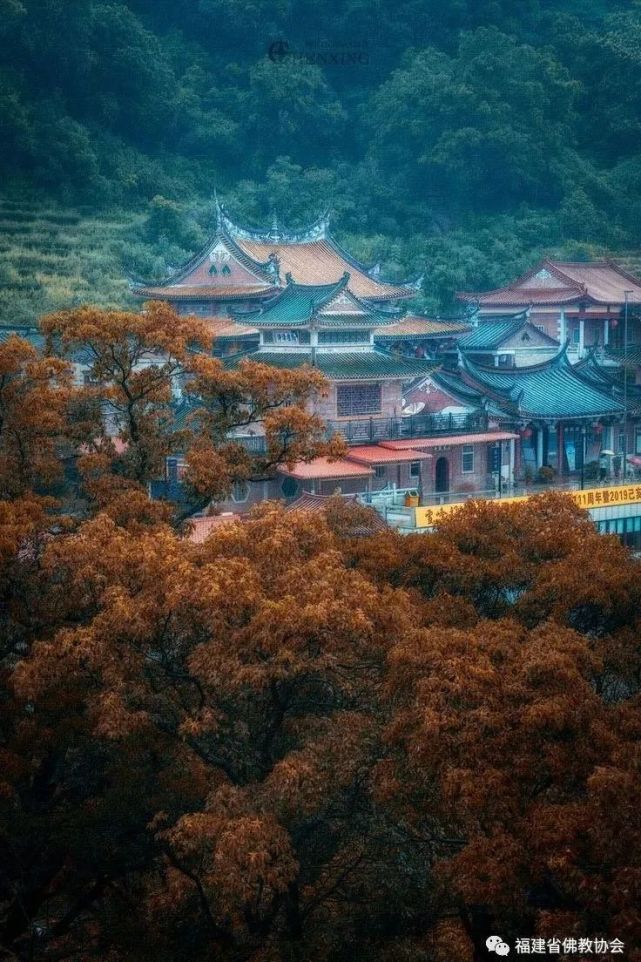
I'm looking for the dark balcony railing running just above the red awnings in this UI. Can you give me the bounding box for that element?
[327,414,488,444]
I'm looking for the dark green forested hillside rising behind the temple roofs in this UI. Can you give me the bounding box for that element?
[0,0,641,322]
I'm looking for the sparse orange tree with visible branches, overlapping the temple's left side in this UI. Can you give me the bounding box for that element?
[42,302,343,514]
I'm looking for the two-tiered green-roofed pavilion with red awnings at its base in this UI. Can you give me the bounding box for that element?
[224,272,440,494]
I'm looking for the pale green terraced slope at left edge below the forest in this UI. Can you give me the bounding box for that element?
[0,199,140,325]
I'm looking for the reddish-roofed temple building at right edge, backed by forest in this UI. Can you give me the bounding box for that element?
[457,259,641,360]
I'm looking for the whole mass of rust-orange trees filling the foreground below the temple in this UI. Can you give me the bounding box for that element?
[0,426,641,962]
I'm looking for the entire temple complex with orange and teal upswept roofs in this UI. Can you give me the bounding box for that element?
[129,216,641,537]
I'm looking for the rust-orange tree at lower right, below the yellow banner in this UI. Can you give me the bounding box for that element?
[370,495,641,960]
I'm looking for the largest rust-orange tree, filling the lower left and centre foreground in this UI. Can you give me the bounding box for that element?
[0,508,431,962]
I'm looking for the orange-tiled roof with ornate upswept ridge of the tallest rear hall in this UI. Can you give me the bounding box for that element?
[133,202,421,318]
